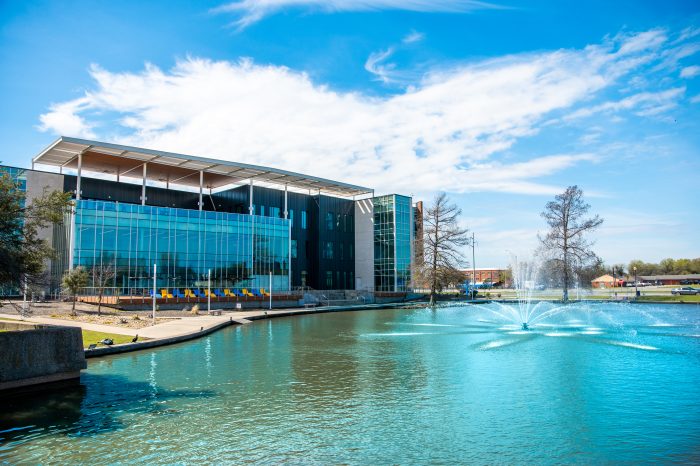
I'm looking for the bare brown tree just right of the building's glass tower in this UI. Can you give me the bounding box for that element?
[421,193,470,306]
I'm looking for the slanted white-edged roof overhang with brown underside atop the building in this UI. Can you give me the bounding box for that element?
[32,136,373,197]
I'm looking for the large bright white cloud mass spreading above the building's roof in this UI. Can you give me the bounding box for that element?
[40,29,681,195]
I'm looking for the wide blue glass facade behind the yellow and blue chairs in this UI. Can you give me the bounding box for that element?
[71,200,290,294]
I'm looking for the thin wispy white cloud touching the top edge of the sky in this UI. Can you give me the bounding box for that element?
[212,0,503,29]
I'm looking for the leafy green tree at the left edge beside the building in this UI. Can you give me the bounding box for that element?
[0,172,72,294]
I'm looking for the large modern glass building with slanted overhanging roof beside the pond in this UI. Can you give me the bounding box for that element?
[5,137,413,296]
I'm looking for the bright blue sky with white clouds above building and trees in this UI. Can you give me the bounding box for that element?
[0,0,700,267]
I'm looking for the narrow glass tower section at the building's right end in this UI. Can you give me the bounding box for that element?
[373,194,413,292]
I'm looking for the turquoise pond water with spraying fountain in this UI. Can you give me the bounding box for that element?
[0,304,700,464]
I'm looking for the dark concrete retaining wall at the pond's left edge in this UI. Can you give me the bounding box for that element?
[0,322,87,393]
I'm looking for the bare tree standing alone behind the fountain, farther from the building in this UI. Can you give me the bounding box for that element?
[539,186,603,302]
